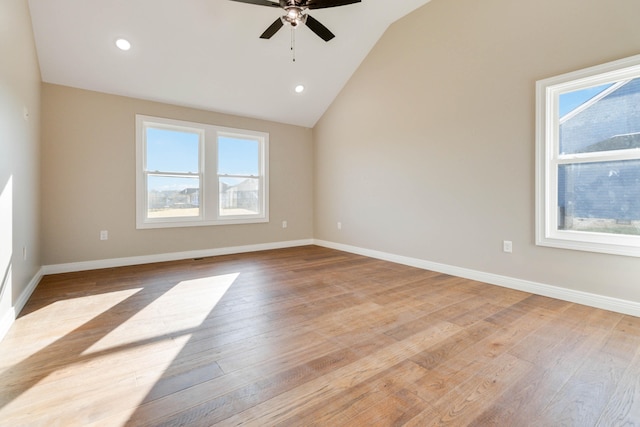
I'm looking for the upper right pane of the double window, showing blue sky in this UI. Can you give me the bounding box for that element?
[218,136,260,176]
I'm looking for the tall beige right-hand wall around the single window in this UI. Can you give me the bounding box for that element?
[314,0,640,301]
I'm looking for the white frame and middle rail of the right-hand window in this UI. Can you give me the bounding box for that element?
[536,55,640,257]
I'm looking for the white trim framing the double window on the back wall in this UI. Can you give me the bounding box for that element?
[136,114,269,229]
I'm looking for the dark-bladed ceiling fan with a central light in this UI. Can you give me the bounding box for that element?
[231,0,361,42]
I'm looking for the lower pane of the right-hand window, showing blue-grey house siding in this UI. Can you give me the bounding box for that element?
[558,160,640,235]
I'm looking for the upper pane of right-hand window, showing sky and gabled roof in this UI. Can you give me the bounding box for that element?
[559,78,640,154]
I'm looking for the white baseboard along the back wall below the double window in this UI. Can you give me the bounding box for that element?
[42,239,313,274]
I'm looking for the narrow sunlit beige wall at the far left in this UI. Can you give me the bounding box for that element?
[0,0,40,328]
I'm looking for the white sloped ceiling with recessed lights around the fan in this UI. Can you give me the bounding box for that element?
[29,0,429,127]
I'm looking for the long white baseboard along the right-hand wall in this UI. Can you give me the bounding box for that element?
[314,240,640,317]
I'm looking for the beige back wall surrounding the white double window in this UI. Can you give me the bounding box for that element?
[42,84,313,265]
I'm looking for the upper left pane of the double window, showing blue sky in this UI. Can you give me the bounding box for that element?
[147,128,200,173]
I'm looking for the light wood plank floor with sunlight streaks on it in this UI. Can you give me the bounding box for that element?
[0,246,640,427]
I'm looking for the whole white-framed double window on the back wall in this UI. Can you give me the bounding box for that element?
[136,115,269,228]
